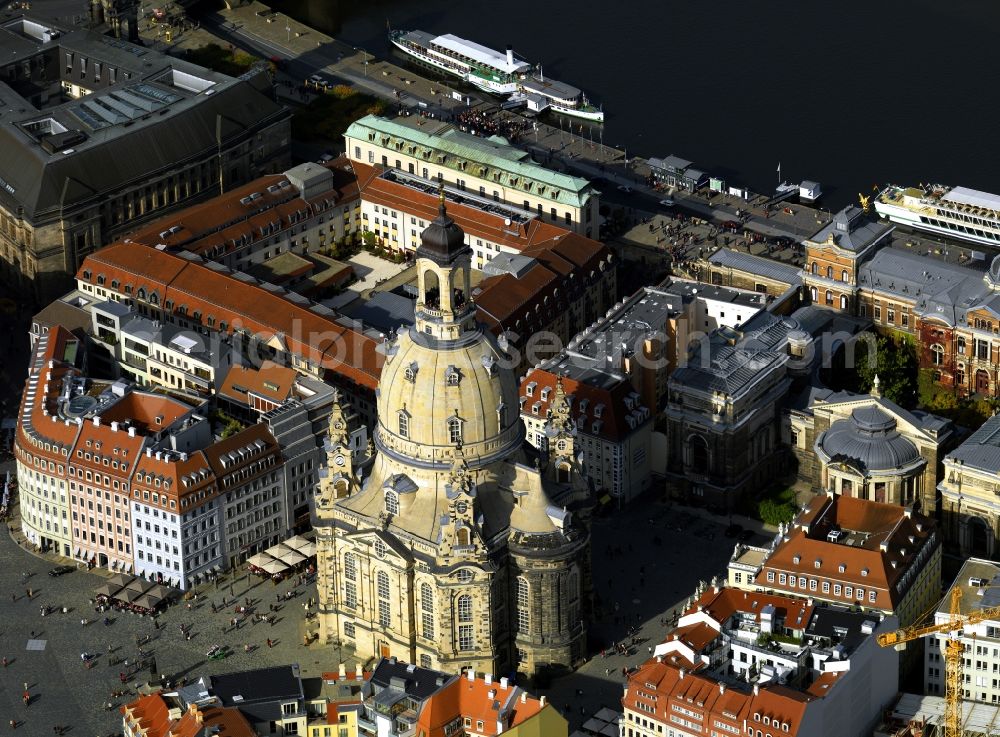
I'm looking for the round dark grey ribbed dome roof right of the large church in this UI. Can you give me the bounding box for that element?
[816,405,920,471]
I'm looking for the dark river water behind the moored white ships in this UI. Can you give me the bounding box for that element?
[274,0,1000,206]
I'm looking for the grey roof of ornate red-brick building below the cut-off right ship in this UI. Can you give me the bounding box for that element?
[858,248,992,326]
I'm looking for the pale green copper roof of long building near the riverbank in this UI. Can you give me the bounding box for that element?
[344,115,593,207]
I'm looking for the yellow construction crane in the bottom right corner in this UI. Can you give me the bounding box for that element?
[877,583,1000,737]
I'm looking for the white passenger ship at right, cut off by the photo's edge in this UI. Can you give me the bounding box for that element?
[874,184,1000,247]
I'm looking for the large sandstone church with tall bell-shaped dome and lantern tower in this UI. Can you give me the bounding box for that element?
[316,198,590,673]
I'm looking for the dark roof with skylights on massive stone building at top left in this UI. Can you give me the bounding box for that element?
[0,25,288,221]
